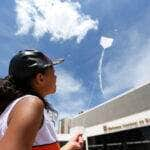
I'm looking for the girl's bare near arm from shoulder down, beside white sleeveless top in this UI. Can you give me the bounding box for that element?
[0,96,44,150]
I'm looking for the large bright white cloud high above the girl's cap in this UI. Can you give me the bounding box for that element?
[16,0,98,43]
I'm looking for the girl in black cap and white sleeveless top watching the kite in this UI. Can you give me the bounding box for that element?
[0,50,83,150]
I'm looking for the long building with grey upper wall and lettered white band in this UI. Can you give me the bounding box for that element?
[58,84,150,150]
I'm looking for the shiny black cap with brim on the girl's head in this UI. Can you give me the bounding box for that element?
[9,49,64,79]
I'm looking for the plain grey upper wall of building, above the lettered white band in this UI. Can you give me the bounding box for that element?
[71,84,150,128]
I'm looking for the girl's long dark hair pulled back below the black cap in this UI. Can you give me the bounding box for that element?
[0,68,57,114]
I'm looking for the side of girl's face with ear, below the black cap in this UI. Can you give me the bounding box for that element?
[33,67,56,96]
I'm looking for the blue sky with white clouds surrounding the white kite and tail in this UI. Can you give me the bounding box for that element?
[0,0,150,117]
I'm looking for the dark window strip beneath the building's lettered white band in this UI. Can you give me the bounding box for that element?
[88,126,150,150]
